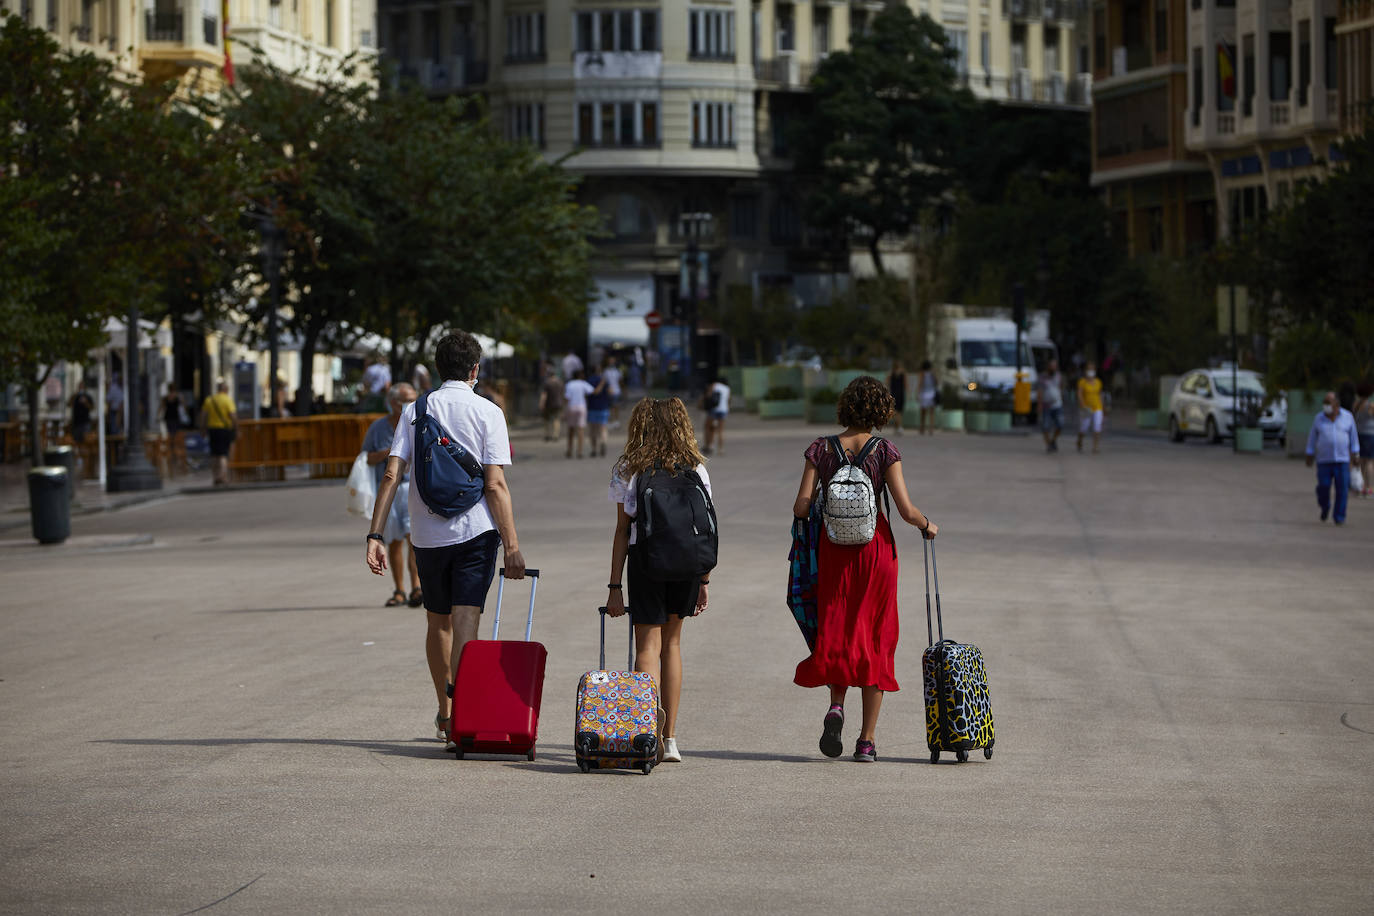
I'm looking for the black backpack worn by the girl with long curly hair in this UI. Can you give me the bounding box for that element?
[635,461,717,582]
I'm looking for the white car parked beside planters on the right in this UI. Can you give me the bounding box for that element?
[1169,365,1287,444]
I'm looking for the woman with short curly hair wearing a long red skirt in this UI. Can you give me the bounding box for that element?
[791,375,940,762]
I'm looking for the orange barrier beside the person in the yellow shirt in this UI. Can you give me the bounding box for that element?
[229,413,383,481]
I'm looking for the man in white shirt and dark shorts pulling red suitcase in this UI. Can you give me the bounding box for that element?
[367,331,525,737]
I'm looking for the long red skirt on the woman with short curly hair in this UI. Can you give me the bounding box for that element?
[793,512,899,691]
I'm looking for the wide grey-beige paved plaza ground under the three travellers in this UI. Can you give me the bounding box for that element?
[0,416,1374,913]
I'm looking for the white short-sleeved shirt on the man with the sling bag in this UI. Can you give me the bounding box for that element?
[392,380,511,547]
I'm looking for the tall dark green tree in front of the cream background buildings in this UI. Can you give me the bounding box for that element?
[793,5,974,273]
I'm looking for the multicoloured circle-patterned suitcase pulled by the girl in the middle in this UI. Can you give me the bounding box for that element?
[573,607,658,776]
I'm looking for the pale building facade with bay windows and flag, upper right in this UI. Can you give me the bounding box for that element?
[1182,0,1342,236]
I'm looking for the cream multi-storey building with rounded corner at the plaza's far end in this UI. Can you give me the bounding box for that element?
[378,0,1090,348]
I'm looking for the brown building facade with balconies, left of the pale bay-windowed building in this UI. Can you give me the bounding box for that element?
[1092,0,1216,258]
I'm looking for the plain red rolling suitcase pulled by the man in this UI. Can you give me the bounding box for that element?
[448,570,548,759]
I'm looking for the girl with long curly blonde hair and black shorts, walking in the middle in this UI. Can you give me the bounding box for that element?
[606,398,710,764]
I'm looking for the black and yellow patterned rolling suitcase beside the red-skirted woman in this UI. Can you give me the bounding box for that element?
[921,540,992,764]
